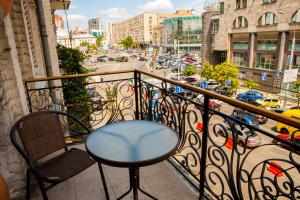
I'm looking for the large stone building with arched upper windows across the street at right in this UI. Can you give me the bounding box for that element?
[202,0,300,92]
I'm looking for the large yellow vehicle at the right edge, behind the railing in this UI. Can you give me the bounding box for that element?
[276,109,300,134]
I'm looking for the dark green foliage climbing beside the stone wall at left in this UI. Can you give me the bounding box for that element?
[57,45,92,125]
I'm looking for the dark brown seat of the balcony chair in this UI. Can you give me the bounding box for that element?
[37,148,95,183]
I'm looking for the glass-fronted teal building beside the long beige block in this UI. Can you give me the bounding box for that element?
[162,15,202,55]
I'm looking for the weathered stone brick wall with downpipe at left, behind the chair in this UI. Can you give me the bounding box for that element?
[0,0,68,199]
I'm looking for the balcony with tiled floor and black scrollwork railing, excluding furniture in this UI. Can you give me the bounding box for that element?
[25,70,300,199]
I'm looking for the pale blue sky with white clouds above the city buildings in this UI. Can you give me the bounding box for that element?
[56,0,211,29]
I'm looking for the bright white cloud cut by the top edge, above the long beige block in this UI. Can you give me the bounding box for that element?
[138,0,174,12]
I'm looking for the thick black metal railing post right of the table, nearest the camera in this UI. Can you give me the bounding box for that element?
[199,95,209,199]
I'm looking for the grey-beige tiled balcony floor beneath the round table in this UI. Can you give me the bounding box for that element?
[32,161,198,200]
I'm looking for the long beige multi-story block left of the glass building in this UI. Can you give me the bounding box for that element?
[112,10,193,45]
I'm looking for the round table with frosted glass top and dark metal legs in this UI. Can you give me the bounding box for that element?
[86,120,180,200]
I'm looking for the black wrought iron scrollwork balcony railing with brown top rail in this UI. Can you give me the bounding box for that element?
[25,70,300,199]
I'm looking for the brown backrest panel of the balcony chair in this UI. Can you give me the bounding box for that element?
[12,111,66,162]
